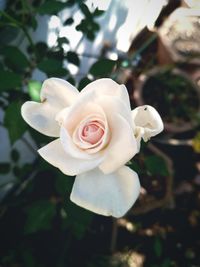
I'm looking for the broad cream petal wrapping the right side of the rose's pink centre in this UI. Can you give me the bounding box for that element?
[99,114,138,173]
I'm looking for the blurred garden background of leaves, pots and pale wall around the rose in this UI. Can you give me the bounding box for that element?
[0,0,200,267]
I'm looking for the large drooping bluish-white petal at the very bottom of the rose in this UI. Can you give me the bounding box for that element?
[70,166,140,218]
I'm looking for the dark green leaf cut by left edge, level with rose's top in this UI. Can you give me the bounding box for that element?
[0,70,22,91]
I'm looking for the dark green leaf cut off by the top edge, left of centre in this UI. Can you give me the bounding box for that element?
[37,0,66,15]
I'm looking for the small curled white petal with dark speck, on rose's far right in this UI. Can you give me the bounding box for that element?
[132,105,164,141]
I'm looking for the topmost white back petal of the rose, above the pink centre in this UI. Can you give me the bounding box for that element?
[80,78,130,107]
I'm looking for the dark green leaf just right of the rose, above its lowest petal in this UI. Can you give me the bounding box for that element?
[144,156,169,176]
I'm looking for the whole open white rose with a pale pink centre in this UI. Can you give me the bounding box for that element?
[21,78,163,217]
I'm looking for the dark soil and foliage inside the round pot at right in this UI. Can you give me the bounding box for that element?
[143,66,199,123]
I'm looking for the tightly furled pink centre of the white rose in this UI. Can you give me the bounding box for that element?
[81,121,104,145]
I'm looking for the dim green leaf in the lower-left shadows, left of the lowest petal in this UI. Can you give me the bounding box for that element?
[24,200,56,234]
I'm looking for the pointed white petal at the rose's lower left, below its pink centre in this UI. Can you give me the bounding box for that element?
[38,139,102,175]
